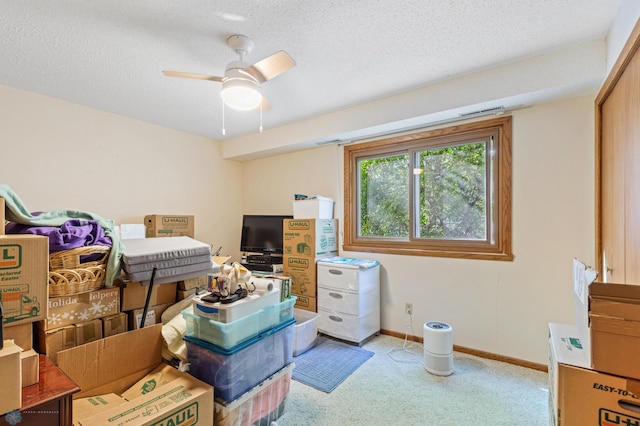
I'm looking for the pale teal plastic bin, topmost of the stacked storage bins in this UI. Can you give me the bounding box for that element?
[182,296,296,349]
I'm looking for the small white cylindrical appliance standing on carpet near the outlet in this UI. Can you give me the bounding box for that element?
[424,321,453,376]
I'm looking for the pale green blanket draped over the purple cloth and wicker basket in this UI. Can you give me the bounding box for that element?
[0,184,124,286]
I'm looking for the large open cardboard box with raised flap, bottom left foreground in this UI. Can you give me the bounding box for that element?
[58,324,213,426]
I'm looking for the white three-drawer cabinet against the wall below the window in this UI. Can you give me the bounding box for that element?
[317,257,380,344]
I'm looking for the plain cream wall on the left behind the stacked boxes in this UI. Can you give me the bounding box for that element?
[0,86,242,254]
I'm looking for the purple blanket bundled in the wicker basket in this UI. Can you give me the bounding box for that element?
[5,219,112,253]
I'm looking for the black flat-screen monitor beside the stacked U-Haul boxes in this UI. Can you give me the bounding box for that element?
[240,215,293,255]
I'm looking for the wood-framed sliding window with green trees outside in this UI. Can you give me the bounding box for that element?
[344,117,513,260]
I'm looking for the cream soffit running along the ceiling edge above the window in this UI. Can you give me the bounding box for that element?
[223,39,607,160]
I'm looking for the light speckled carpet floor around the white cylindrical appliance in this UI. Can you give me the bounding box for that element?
[277,335,549,426]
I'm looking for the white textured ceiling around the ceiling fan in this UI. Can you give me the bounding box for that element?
[0,0,619,140]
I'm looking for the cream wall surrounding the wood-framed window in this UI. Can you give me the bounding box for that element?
[243,96,594,364]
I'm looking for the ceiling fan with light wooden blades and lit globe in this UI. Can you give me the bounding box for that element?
[162,35,296,111]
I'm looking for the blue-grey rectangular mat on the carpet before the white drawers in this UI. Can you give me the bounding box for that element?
[291,337,374,393]
